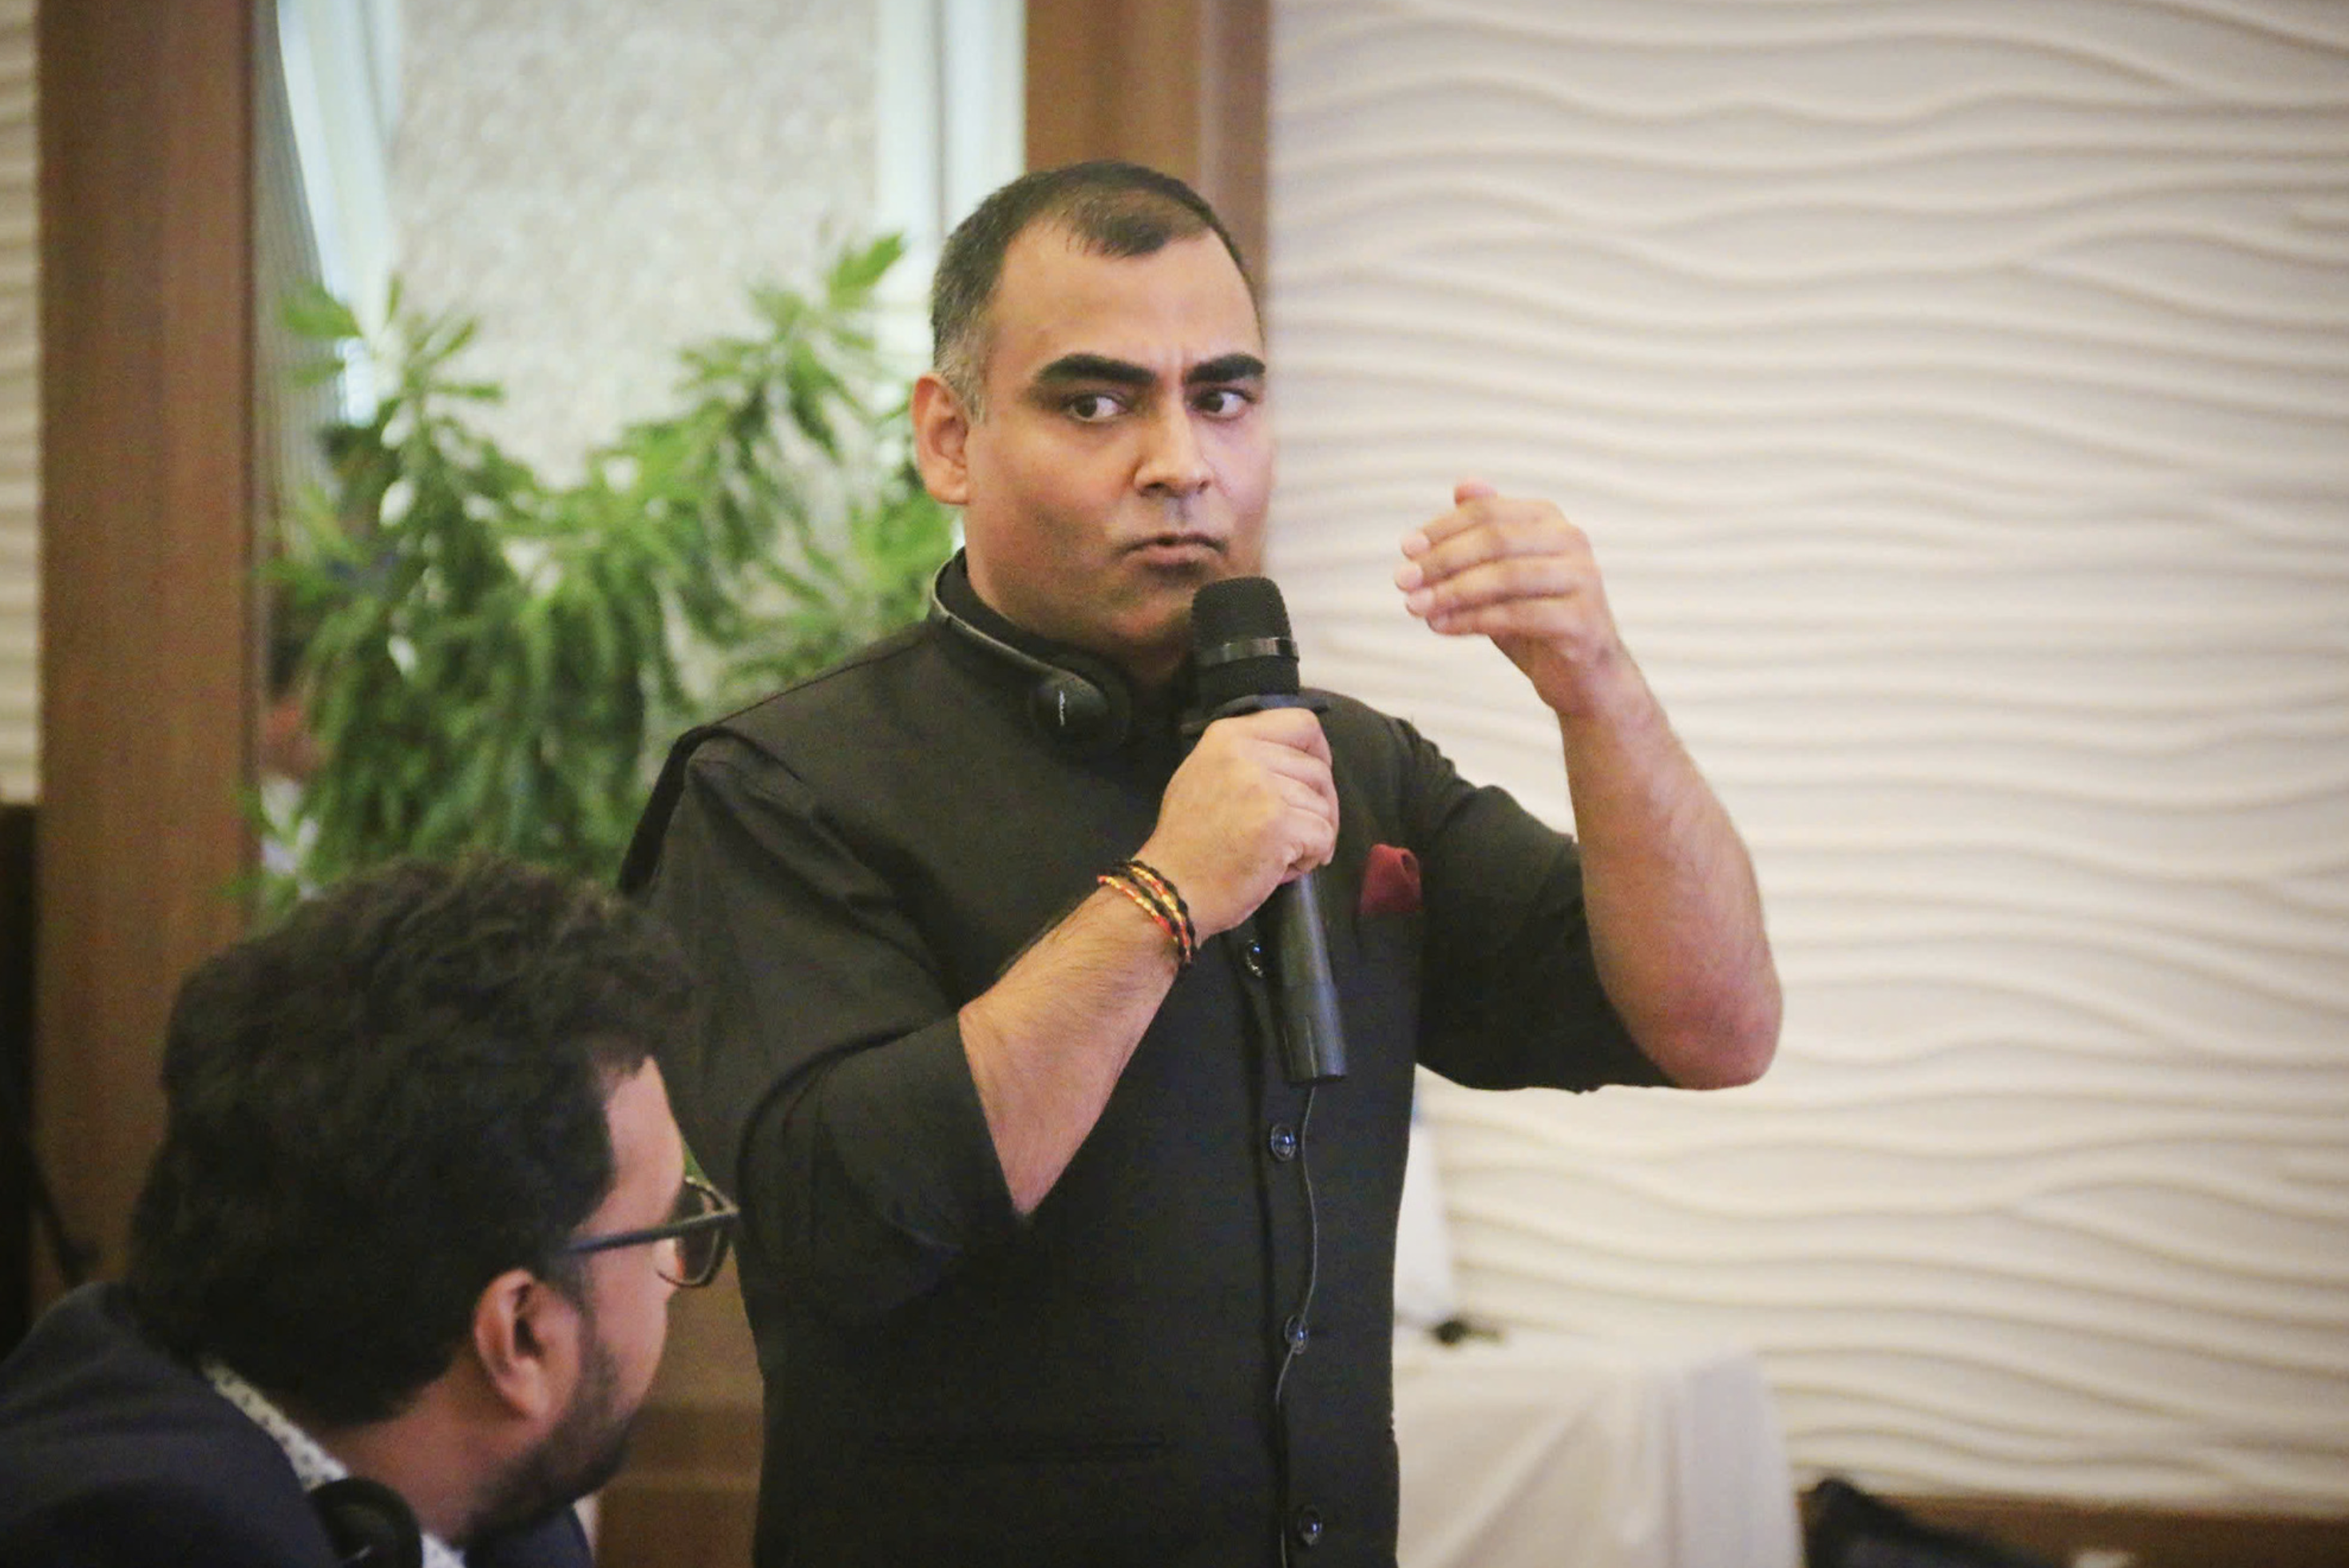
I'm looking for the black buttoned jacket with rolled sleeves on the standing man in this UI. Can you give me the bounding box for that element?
[623,563,1661,1568]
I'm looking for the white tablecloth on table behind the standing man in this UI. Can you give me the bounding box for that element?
[1396,1331,1802,1568]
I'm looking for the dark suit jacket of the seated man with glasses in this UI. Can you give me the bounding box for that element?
[0,1284,589,1568]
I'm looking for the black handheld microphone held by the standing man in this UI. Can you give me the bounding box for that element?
[1191,577,1346,1084]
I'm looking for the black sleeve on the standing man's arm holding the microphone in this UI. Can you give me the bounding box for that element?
[648,735,1017,1319]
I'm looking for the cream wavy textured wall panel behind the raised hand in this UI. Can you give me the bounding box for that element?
[1271,0,2349,1511]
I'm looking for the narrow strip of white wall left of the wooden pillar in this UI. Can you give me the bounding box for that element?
[0,0,40,801]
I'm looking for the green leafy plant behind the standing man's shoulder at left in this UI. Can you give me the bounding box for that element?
[263,240,952,906]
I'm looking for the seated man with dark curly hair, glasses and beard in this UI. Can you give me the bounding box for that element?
[0,861,731,1568]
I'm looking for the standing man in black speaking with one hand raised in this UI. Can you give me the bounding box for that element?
[625,164,1778,1568]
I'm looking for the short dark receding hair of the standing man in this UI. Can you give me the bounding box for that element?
[930,160,1257,415]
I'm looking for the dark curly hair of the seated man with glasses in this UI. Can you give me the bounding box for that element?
[129,859,693,1425]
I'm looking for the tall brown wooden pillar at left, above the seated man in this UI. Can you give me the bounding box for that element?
[33,0,256,1289]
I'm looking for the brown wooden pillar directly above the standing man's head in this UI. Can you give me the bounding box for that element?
[1027,0,1274,284]
